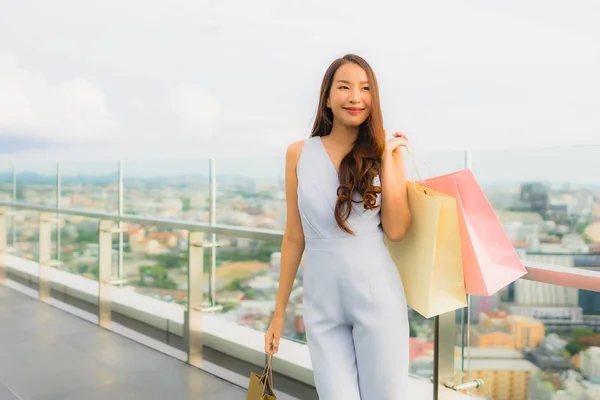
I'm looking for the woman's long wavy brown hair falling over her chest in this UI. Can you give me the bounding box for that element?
[310,54,385,234]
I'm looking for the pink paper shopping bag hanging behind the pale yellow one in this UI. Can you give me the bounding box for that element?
[425,170,527,296]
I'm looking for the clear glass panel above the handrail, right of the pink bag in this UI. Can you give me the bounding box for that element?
[473,146,600,256]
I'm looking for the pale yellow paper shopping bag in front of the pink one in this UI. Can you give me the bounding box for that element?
[385,182,467,318]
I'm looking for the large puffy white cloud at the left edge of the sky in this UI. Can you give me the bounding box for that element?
[0,54,117,142]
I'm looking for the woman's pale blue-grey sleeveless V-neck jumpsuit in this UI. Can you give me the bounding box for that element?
[297,137,409,400]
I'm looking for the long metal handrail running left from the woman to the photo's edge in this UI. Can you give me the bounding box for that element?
[0,201,283,241]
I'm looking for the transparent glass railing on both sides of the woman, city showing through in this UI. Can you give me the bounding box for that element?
[0,147,600,400]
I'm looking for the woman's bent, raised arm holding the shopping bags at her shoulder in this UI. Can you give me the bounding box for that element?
[381,134,411,241]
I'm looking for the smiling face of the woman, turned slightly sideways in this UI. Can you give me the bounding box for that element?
[327,63,371,128]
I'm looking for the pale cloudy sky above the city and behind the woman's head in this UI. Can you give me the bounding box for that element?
[0,0,600,180]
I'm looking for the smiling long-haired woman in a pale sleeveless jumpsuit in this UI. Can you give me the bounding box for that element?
[265,55,410,400]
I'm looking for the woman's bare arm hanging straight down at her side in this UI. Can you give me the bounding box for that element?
[274,141,304,319]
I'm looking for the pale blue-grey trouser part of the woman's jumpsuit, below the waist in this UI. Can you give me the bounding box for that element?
[304,235,409,400]
